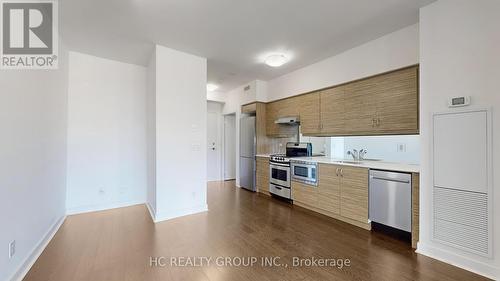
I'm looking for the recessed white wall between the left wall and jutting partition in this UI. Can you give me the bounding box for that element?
[67,52,147,213]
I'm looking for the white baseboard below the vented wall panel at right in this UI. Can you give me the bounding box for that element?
[415,242,500,280]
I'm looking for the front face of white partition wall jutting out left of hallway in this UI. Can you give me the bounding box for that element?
[155,45,207,220]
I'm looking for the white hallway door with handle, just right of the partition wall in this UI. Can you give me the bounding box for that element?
[207,112,222,181]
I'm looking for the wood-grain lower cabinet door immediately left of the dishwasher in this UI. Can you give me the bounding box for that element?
[340,166,368,223]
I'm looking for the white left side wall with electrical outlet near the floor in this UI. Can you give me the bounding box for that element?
[0,45,67,280]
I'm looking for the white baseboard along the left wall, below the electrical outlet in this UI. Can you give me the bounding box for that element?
[7,216,66,281]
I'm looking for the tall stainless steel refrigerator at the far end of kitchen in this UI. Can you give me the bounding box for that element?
[240,116,257,191]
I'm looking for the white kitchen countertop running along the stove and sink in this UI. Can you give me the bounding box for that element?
[256,154,420,173]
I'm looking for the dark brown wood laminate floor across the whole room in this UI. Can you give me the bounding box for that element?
[24,181,486,281]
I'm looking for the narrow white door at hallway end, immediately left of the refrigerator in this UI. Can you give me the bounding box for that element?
[224,114,237,180]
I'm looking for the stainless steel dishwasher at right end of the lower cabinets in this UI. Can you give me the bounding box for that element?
[369,170,411,232]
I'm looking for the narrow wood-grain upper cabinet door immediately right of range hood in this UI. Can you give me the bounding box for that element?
[298,92,321,135]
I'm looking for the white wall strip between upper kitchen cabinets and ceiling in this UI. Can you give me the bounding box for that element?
[267,24,419,101]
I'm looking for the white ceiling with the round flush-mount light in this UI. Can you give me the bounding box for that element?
[59,0,434,91]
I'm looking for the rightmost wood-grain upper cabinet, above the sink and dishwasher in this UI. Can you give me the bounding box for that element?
[344,67,419,135]
